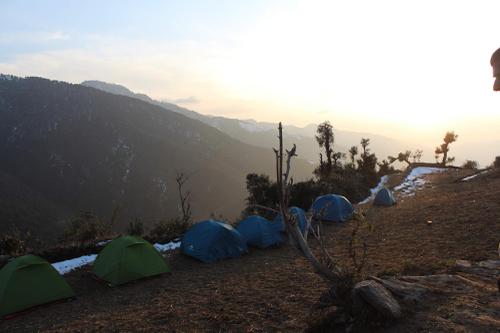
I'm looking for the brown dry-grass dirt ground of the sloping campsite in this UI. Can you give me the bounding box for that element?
[0,171,500,332]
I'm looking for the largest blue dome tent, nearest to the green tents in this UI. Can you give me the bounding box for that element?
[181,220,248,263]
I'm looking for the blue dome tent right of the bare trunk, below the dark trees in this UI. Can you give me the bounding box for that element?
[311,194,354,222]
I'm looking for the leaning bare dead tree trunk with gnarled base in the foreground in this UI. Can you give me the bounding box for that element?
[273,123,436,319]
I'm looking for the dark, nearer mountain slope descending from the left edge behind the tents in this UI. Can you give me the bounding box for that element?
[0,76,312,236]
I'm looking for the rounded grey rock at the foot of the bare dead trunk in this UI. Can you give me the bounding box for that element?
[353,280,402,319]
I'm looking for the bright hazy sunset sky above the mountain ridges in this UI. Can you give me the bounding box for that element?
[0,0,500,142]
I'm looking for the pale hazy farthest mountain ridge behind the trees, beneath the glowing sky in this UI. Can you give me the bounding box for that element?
[82,81,500,166]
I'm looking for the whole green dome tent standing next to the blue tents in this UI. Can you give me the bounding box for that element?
[93,236,170,286]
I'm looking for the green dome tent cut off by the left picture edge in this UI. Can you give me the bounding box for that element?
[0,255,75,317]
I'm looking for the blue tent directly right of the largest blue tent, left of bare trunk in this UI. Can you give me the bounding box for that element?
[236,215,283,249]
